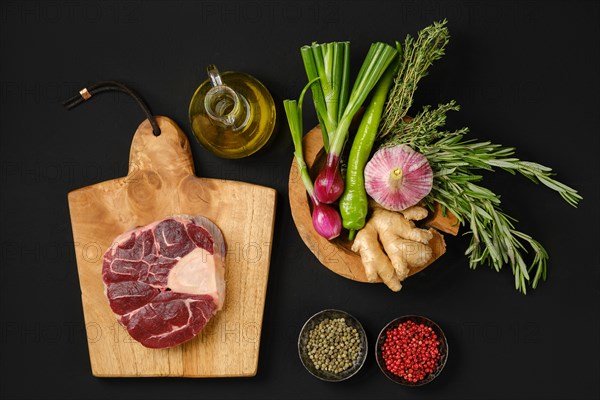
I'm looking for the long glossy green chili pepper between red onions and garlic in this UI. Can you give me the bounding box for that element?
[340,47,400,240]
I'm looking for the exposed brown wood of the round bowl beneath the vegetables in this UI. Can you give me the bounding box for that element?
[288,126,447,282]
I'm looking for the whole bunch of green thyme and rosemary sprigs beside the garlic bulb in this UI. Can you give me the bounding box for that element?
[379,21,582,293]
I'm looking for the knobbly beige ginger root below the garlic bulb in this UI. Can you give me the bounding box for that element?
[352,206,433,292]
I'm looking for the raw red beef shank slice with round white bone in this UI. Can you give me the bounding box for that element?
[102,215,225,348]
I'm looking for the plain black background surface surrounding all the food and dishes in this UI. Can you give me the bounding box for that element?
[0,1,600,399]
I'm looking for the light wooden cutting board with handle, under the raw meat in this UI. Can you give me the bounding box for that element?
[69,117,276,377]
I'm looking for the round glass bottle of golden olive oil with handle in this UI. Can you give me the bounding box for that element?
[189,65,276,158]
